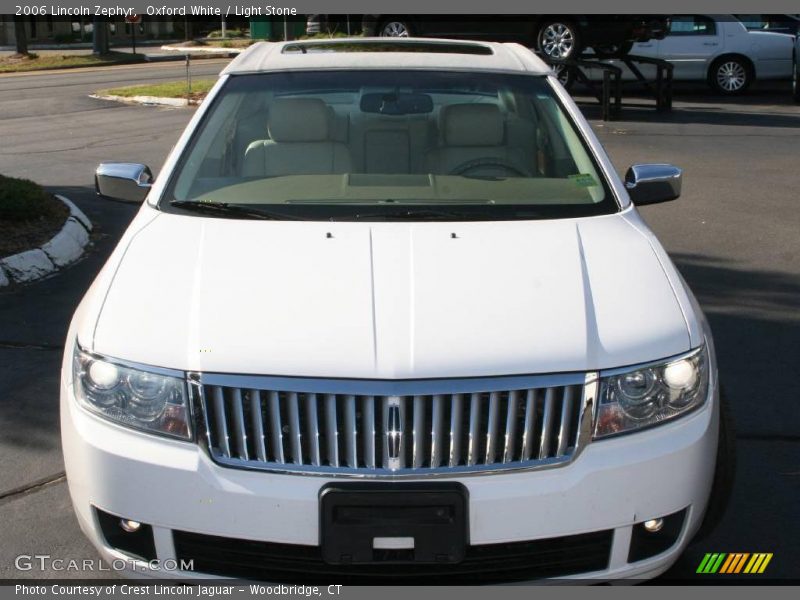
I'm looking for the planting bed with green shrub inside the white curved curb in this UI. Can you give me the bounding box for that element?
[0,175,69,257]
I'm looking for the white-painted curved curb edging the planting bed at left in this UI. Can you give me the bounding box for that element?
[0,194,92,287]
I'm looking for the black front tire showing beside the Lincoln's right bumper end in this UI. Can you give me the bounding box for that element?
[692,387,736,543]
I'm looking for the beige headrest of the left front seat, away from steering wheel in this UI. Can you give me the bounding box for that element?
[267,98,329,142]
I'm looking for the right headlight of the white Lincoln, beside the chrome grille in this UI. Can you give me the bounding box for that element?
[594,346,708,438]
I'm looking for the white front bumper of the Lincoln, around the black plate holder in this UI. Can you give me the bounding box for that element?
[61,376,718,579]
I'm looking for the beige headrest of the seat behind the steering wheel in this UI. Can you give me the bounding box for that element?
[441,104,503,146]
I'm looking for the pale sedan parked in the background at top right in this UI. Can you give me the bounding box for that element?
[631,15,793,95]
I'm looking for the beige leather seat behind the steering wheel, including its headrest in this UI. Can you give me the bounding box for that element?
[425,104,530,177]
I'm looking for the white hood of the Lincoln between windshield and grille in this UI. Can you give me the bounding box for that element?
[92,214,689,379]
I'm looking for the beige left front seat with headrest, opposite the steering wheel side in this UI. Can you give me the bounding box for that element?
[242,98,352,177]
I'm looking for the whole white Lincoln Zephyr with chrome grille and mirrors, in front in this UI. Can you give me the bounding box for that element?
[61,38,732,584]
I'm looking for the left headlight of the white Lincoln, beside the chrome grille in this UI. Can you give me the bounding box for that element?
[72,346,191,439]
